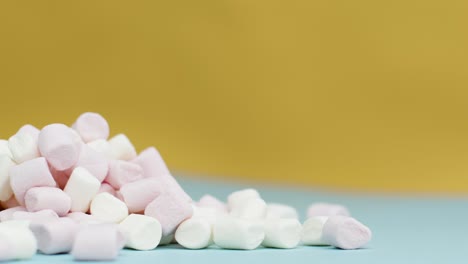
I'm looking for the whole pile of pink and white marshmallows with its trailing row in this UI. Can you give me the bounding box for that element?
[0,113,371,260]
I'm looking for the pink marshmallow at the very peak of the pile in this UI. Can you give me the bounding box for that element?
[72,112,109,143]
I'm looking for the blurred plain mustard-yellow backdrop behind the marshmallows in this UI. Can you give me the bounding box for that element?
[0,0,468,193]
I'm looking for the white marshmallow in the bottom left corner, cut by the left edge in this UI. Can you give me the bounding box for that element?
[0,222,37,259]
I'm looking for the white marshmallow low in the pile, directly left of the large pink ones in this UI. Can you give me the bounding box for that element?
[90,192,128,223]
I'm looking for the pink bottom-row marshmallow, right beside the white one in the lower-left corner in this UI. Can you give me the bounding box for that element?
[30,217,78,254]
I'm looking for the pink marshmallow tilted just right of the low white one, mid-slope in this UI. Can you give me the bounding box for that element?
[119,178,162,213]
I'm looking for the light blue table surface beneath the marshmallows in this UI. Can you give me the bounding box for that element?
[24,177,468,264]
